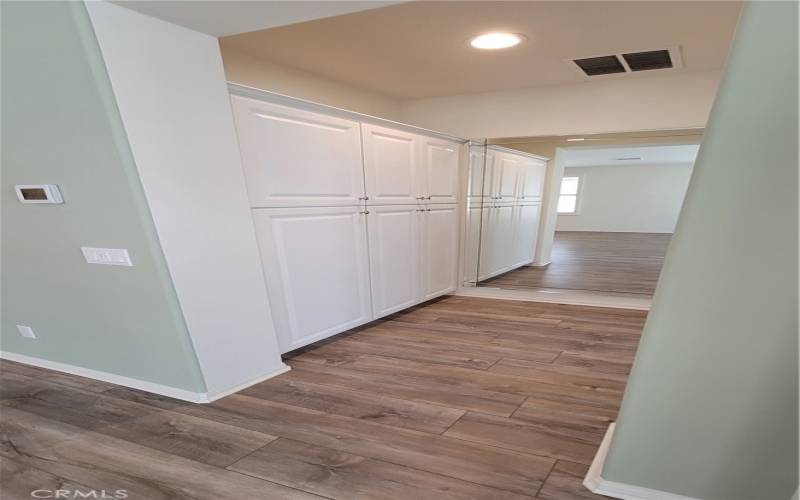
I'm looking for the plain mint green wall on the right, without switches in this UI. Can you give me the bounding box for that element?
[602,2,798,500]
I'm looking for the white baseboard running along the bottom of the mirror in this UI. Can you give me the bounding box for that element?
[453,286,653,311]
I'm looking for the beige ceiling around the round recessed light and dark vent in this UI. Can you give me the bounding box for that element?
[221,1,741,99]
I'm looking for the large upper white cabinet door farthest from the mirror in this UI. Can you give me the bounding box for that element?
[231,96,364,207]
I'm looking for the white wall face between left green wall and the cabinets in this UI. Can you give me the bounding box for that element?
[86,2,286,399]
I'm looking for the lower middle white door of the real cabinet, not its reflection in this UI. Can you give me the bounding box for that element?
[367,205,422,319]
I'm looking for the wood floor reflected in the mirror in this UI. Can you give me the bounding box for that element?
[481,231,672,296]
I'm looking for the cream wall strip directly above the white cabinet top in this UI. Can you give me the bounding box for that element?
[220,47,400,121]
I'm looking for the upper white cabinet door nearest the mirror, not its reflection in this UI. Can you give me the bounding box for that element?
[422,137,461,203]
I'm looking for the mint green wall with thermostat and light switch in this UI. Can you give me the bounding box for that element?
[0,1,205,392]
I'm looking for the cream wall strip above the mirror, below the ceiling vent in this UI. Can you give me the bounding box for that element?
[401,71,721,139]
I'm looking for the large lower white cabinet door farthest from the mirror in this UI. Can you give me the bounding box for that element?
[253,207,372,352]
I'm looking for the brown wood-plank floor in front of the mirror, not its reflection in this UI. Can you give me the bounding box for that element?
[0,297,646,500]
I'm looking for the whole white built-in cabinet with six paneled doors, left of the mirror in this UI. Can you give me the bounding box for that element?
[232,95,462,352]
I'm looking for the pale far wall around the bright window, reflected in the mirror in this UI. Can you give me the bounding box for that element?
[556,164,692,233]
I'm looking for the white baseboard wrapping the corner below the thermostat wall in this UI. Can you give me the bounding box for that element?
[0,351,291,403]
